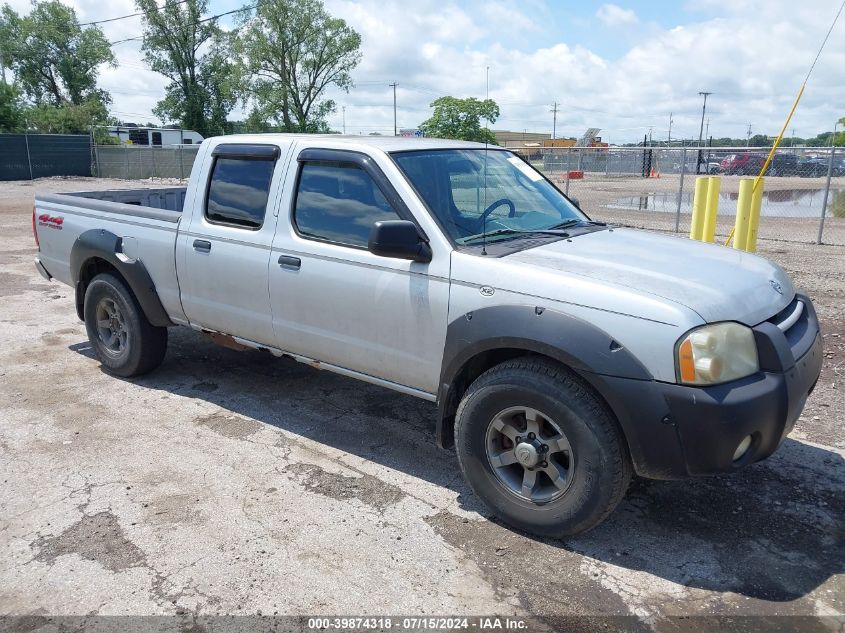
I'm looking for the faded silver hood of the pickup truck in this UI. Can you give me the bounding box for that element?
[504,228,795,325]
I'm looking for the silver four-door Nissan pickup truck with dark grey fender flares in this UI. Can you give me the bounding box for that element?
[32,135,822,536]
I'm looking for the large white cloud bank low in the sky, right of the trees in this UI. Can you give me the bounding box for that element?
[324,0,845,142]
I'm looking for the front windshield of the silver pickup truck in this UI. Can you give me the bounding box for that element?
[393,149,587,244]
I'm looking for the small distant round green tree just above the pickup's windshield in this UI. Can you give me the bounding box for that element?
[420,97,499,145]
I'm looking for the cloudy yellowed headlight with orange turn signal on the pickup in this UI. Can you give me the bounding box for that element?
[675,323,760,385]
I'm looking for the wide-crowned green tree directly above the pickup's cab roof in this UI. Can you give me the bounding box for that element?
[238,0,361,132]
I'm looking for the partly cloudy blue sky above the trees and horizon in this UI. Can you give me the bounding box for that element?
[9,0,845,143]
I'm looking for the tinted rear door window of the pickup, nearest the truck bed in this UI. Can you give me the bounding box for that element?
[205,157,276,230]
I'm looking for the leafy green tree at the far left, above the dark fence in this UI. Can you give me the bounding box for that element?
[0,0,115,107]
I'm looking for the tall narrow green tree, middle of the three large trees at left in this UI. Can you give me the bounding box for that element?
[136,0,238,136]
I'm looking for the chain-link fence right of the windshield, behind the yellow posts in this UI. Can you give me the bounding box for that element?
[536,147,845,245]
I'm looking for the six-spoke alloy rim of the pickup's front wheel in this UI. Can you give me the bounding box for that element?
[485,406,575,504]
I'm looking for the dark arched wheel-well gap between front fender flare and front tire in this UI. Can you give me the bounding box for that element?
[438,348,631,464]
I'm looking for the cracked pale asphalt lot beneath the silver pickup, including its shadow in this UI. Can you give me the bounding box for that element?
[0,180,845,631]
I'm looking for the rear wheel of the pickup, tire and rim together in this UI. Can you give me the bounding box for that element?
[84,273,167,378]
